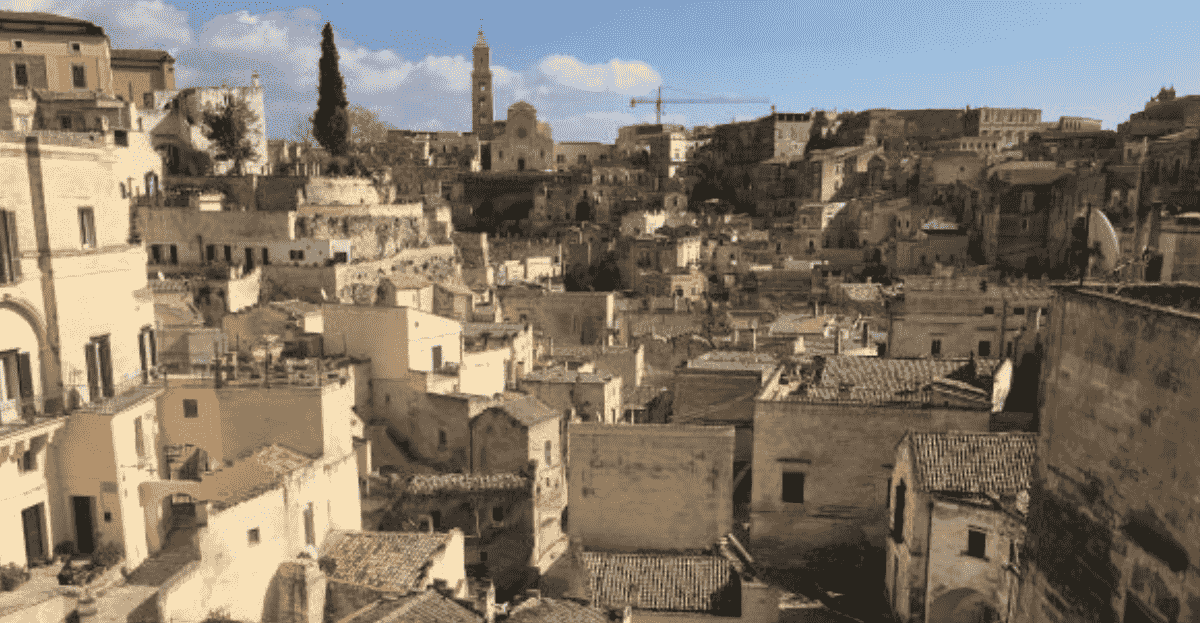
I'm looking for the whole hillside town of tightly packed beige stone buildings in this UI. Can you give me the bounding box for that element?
[0,11,1200,623]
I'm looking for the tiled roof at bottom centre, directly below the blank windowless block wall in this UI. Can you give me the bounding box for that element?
[583,552,734,612]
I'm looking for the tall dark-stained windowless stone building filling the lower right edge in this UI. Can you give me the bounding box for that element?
[1015,282,1200,623]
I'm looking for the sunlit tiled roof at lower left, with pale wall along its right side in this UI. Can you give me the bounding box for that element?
[322,531,450,593]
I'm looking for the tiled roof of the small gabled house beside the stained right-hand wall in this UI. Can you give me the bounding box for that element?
[907,432,1038,495]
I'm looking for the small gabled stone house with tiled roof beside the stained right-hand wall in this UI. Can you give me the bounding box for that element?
[884,432,1037,622]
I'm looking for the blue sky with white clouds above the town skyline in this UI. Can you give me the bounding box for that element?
[0,0,1200,142]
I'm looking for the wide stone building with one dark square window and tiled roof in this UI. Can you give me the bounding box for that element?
[750,355,1012,562]
